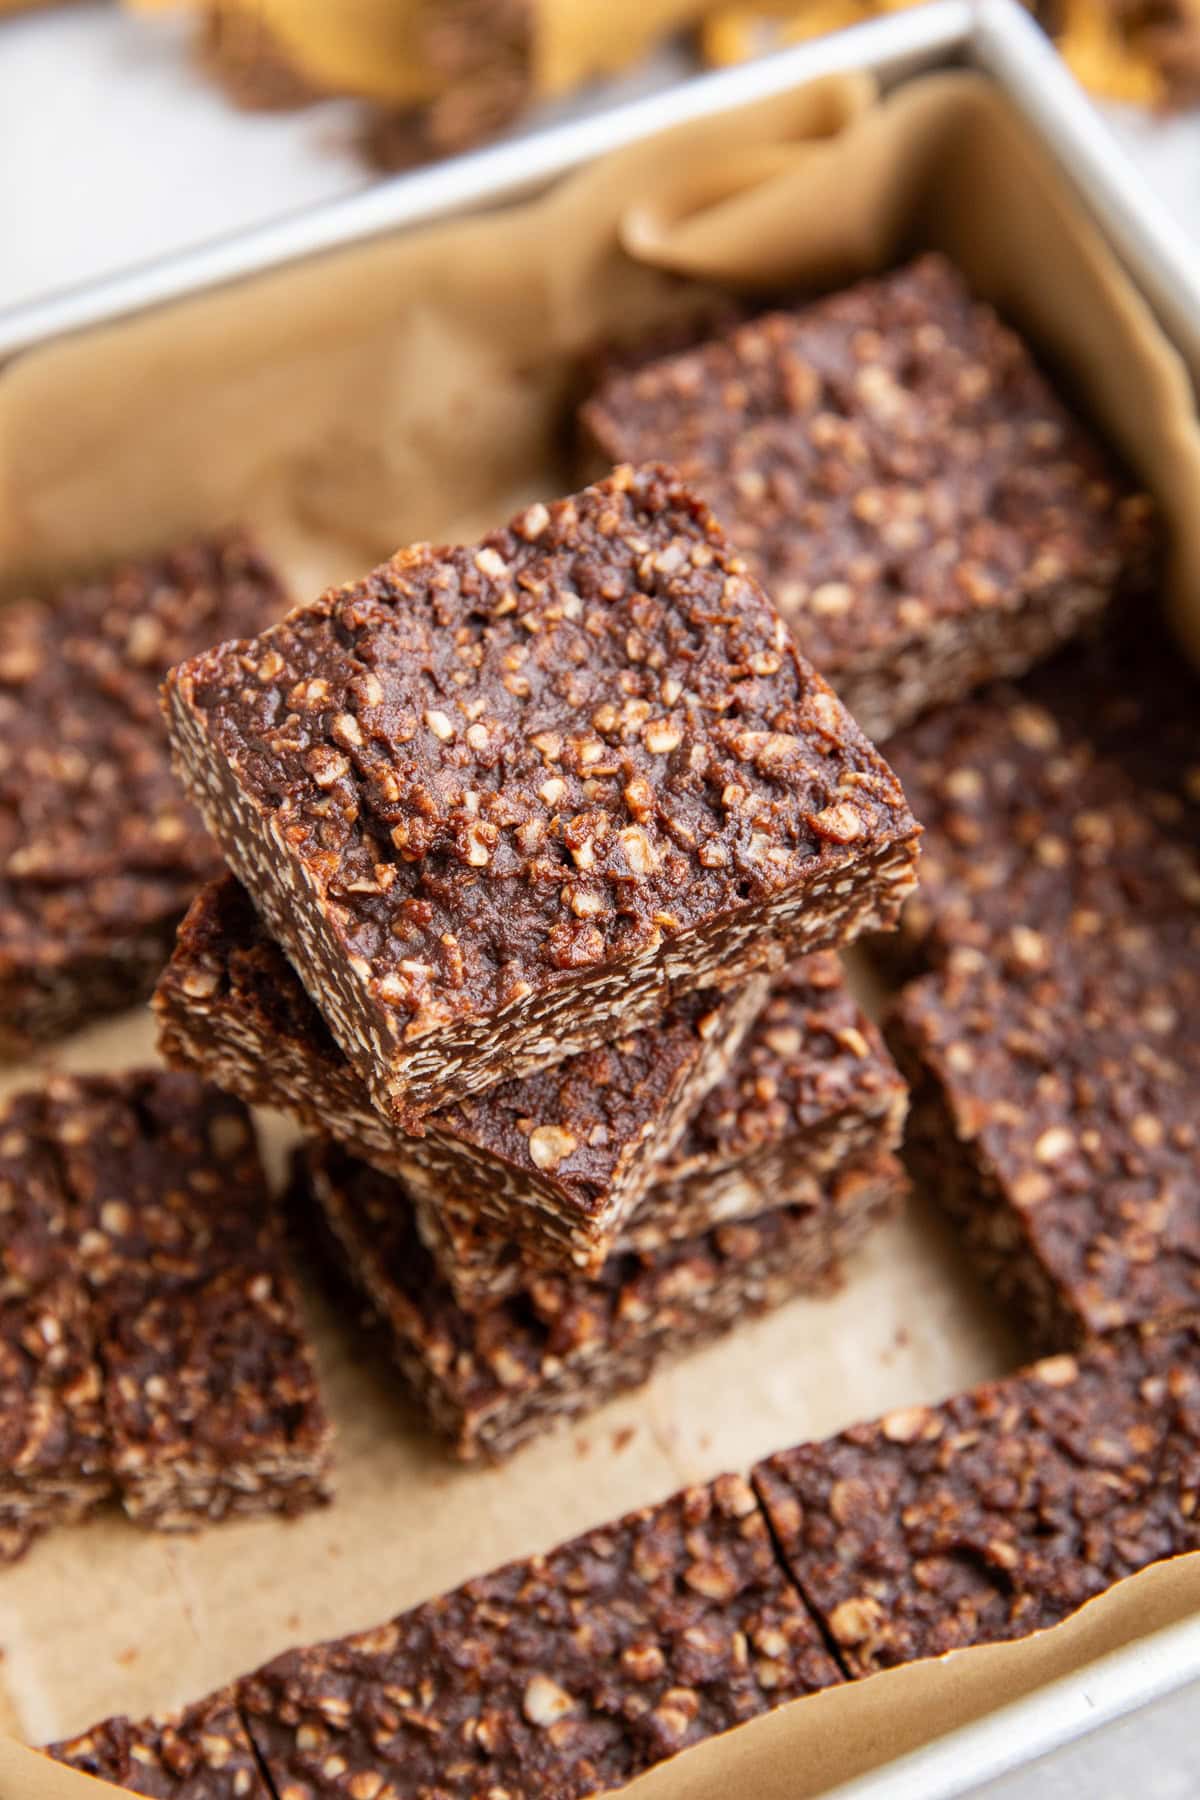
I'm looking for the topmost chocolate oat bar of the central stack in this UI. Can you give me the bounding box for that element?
[167,468,918,1116]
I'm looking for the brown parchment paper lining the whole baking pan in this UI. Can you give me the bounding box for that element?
[0,74,1200,1800]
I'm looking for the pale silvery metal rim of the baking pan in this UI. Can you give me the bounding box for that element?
[0,0,1200,1800]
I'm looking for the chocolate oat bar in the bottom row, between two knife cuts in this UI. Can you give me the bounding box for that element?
[237,1476,842,1800]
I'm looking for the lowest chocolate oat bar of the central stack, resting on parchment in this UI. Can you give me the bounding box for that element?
[293,1145,905,1462]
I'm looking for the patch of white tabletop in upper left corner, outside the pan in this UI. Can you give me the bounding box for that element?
[0,4,367,306]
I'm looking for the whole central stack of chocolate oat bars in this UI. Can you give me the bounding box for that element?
[157,466,918,1456]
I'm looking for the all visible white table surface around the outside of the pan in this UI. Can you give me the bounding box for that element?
[0,0,1200,1800]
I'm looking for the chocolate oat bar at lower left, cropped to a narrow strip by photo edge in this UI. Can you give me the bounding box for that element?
[0,1094,112,1562]
